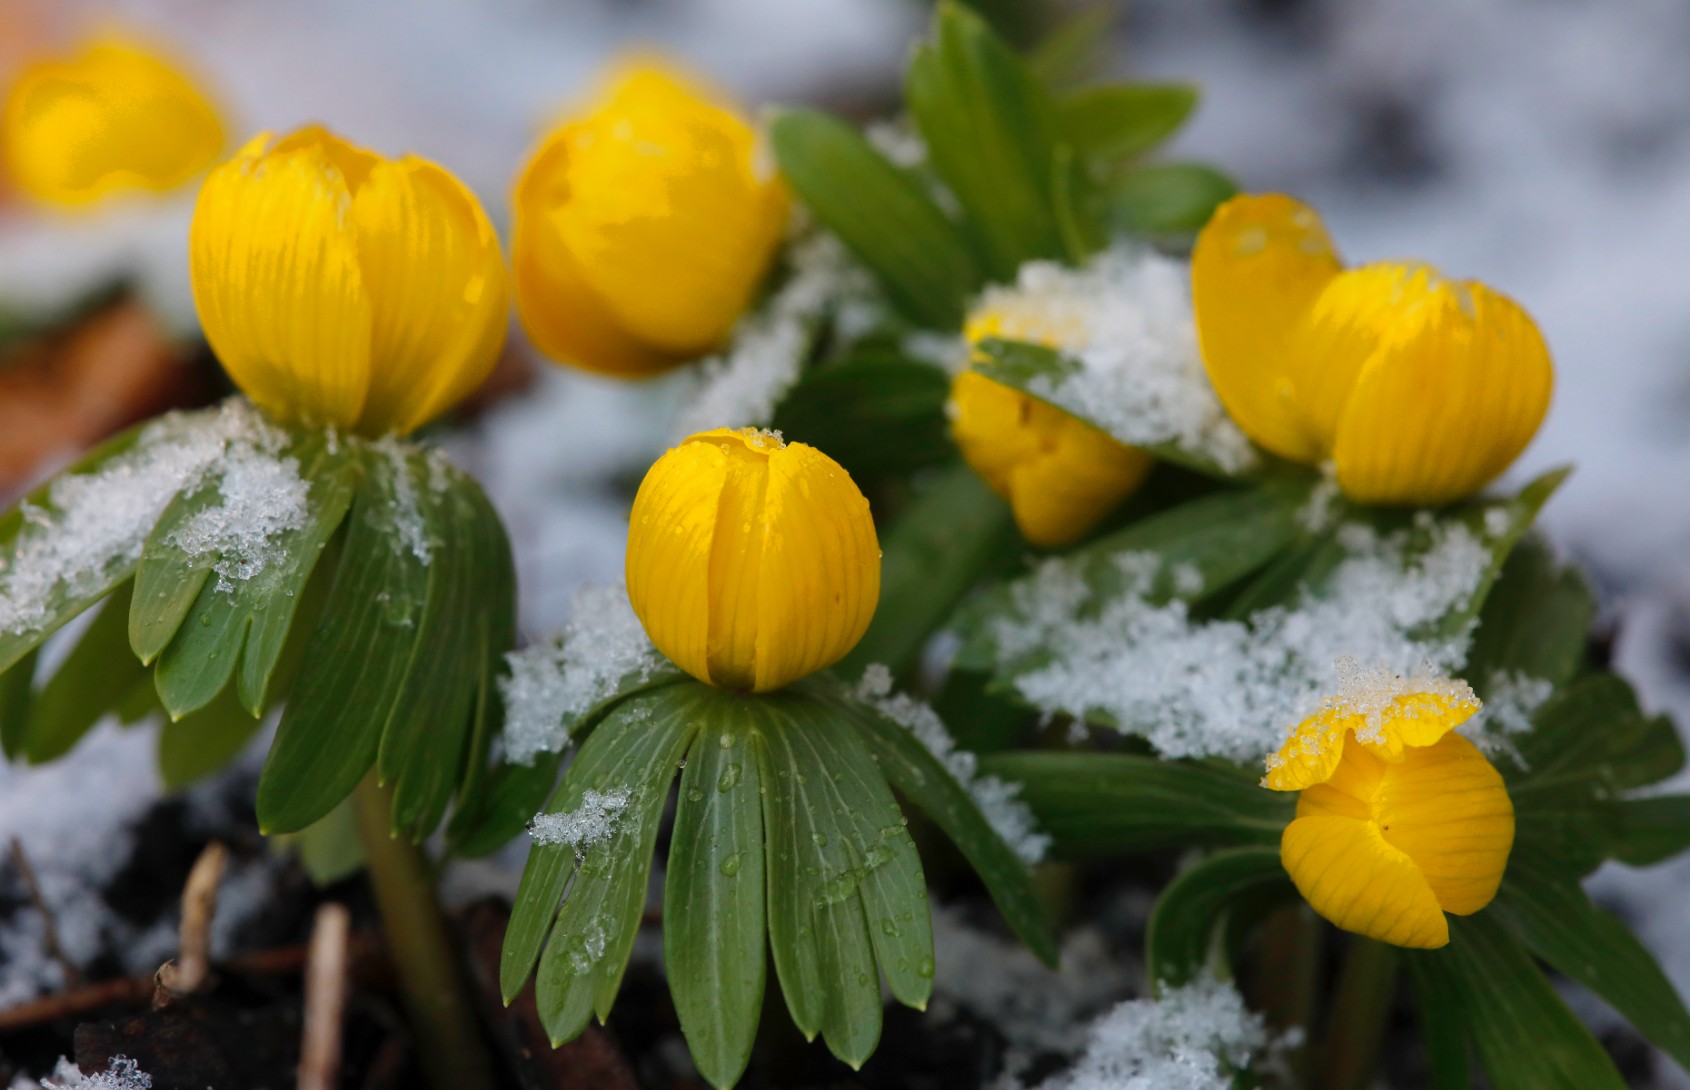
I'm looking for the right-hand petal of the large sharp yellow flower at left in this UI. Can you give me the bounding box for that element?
[353,155,509,434]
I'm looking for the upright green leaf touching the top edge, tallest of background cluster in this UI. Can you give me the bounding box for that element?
[904,0,1065,282]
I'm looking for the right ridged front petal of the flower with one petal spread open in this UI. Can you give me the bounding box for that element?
[1333,282,1555,505]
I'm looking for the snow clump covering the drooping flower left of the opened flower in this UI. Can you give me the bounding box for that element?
[972,245,1256,473]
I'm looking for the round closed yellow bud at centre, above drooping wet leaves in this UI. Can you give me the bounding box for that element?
[627,428,880,693]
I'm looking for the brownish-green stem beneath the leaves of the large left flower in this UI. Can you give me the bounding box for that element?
[352,774,493,1090]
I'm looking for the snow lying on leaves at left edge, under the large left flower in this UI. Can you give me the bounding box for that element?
[0,399,289,635]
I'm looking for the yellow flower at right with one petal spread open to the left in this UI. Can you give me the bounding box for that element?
[1191,194,1555,504]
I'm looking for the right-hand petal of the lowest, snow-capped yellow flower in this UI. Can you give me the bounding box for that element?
[1379,733,1514,916]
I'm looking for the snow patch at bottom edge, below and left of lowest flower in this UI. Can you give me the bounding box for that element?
[1039,977,1269,1090]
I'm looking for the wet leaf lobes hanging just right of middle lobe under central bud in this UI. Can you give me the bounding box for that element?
[745,686,933,1068]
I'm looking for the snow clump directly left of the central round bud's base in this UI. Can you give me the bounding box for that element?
[499,586,664,764]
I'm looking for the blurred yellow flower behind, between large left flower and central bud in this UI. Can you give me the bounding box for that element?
[512,64,788,377]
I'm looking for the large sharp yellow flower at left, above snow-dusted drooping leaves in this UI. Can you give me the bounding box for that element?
[189,127,509,436]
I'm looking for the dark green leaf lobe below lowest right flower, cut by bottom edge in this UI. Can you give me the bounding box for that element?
[1403,913,1626,1090]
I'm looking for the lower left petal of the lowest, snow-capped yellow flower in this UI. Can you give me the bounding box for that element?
[1279,816,1450,950]
